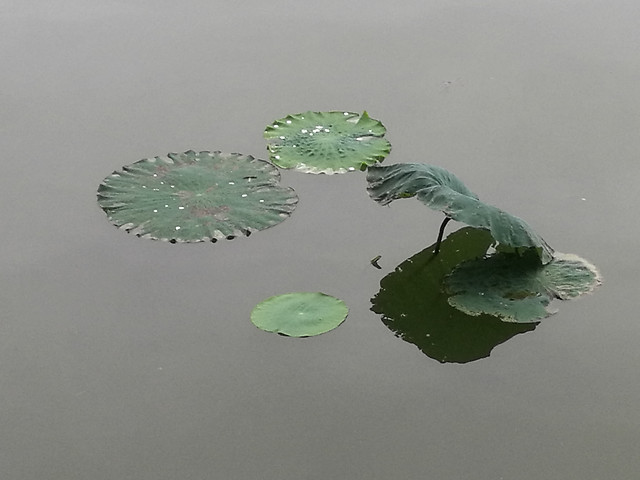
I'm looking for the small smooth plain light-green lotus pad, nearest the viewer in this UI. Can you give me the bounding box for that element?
[251,292,349,337]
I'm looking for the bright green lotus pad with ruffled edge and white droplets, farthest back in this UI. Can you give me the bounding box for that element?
[264,112,391,174]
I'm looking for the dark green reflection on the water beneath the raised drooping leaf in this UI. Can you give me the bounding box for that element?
[371,227,537,363]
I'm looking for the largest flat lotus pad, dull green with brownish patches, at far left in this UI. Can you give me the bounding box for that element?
[98,151,298,243]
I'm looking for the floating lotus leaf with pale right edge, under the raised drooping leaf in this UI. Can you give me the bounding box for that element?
[445,248,601,323]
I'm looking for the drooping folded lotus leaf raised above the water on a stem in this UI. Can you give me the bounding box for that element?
[367,163,553,263]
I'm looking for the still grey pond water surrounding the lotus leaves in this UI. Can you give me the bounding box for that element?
[0,0,640,480]
